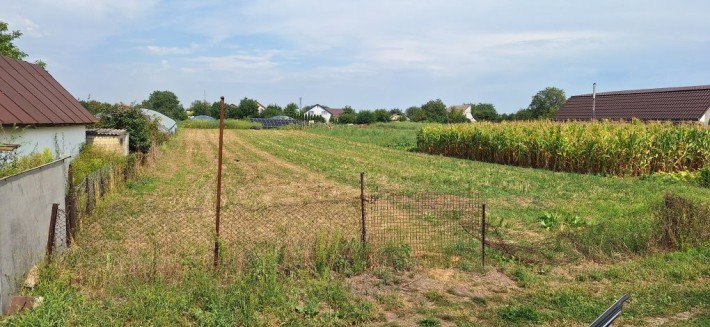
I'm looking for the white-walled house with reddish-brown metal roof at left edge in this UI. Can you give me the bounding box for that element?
[0,56,97,160]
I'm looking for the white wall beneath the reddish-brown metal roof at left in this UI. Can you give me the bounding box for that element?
[0,125,86,157]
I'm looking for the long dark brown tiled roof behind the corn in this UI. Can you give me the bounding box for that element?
[555,85,710,121]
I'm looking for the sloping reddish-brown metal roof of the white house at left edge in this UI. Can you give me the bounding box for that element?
[0,56,96,125]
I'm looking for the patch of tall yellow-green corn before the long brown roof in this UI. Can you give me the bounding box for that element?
[417,121,710,176]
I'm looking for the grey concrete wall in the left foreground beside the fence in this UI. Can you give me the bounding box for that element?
[0,159,68,313]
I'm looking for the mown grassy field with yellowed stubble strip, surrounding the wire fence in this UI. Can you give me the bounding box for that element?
[5,127,710,326]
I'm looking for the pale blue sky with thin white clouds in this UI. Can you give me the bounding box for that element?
[0,0,710,113]
